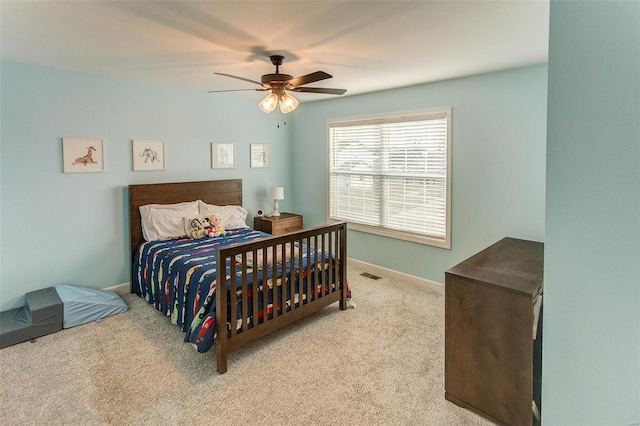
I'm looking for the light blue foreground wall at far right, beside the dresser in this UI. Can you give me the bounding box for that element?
[542,1,640,425]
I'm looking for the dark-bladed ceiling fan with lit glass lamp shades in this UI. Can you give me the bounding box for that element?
[209,55,347,114]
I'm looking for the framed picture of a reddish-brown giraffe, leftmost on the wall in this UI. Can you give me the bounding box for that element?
[62,138,104,173]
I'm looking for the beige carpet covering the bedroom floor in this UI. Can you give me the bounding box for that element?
[0,268,492,425]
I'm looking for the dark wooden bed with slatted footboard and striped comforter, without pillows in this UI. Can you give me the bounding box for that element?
[129,179,349,374]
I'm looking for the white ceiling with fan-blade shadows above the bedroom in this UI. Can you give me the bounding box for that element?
[0,0,549,102]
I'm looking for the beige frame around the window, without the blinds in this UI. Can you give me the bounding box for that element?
[326,107,452,249]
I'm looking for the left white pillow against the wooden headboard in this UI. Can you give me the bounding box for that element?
[140,201,198,241]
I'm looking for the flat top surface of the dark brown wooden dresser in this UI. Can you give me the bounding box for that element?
[446,238,544,296]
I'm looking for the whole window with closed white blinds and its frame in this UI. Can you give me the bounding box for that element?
[327,108,451,248]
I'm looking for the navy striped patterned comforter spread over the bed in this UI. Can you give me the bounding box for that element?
[132,229,344,352]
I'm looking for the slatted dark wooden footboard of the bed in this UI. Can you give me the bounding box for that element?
[215,222,348,374]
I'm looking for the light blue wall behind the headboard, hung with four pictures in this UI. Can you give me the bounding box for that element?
[0,62,292,310]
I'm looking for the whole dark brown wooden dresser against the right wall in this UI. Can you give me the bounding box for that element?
[445,238,544,425]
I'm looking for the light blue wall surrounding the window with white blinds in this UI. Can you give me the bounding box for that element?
[292,66,547,283]
